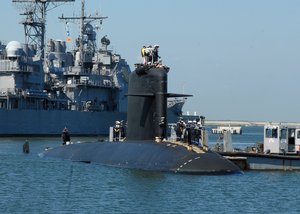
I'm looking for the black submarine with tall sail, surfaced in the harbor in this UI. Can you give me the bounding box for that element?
[42,59,241,175]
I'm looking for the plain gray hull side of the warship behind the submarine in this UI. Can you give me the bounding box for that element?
[0,109,126,136]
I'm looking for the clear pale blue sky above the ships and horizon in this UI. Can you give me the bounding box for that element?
[0,0,300,122]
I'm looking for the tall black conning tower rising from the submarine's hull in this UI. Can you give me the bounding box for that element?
[126,65,169,140]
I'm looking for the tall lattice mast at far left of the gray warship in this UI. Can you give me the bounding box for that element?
[12,0,75,60]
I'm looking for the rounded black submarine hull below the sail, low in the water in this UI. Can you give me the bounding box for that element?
[42,141,240,175]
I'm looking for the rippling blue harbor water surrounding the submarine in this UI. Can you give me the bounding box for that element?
[0,129,300,213]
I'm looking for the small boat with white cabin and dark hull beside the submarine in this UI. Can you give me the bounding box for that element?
[214,124,300,171]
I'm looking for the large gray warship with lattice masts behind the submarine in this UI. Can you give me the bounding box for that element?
[0,0,185,136]
